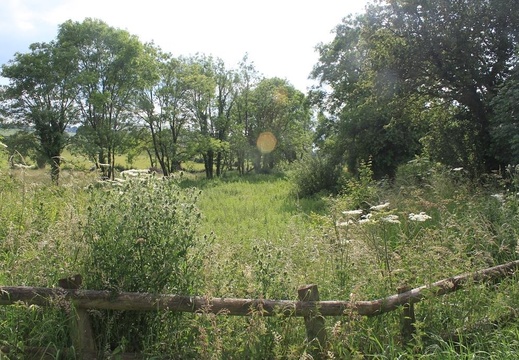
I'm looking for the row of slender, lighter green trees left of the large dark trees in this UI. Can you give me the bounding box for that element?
[1,19,311,182]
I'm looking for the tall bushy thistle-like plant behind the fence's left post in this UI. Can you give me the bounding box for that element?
[83,178,208,352]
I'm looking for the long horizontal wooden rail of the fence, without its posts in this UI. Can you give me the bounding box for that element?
[0,260,519,316]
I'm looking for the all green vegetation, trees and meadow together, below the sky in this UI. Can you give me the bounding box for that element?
[0,0,519,359]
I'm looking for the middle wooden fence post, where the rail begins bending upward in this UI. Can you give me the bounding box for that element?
[297,285,327,359]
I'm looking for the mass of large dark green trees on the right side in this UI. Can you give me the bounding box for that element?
[309,0,519,184]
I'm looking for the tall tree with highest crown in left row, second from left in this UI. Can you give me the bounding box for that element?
[58,19,151,177]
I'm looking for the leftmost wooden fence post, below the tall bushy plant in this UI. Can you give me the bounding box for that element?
[59,274,97,360]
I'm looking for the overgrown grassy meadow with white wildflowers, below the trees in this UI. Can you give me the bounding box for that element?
[0,159,519,359]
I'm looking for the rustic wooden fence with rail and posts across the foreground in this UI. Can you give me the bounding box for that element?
[0,260,519,358]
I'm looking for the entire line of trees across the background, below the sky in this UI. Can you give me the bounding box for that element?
[2,0,519,193]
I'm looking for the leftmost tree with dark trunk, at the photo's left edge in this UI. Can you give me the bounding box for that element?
[2,42,77,184]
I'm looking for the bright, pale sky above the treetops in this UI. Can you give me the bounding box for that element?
[0,0,368,92]
